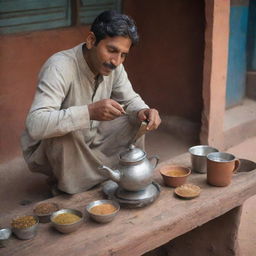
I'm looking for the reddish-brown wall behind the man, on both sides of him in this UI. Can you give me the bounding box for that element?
[0,0,204,161]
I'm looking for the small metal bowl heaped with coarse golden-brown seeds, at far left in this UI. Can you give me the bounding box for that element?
[11,215,39,240]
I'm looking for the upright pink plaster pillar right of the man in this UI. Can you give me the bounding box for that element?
[200,0,230,150]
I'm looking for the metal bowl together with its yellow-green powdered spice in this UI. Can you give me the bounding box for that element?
[51,209,83,233]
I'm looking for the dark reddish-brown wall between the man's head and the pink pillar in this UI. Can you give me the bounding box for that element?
[123,0,205,122]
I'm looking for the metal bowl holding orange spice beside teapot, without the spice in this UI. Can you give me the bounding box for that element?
[86,200,120,223]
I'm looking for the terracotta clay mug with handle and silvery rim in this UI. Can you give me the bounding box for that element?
[207,152,240,187]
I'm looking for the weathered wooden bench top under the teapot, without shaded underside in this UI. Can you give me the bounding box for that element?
[0,154,256,256]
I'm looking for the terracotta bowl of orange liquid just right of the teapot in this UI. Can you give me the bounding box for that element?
[159,165,191,188]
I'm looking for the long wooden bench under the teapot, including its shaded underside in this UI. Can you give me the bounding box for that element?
[0,154,256,256]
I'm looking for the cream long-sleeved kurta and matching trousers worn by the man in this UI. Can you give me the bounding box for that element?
[21,44,148,193]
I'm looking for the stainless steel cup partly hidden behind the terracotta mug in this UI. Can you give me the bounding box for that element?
[188,145,219,173]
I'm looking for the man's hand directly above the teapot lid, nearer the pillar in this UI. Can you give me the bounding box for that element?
[138,108,161,131]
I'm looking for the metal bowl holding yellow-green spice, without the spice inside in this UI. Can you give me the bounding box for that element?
[50,209,84,234]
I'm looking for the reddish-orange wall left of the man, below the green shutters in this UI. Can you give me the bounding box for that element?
[0,27,89,161]
